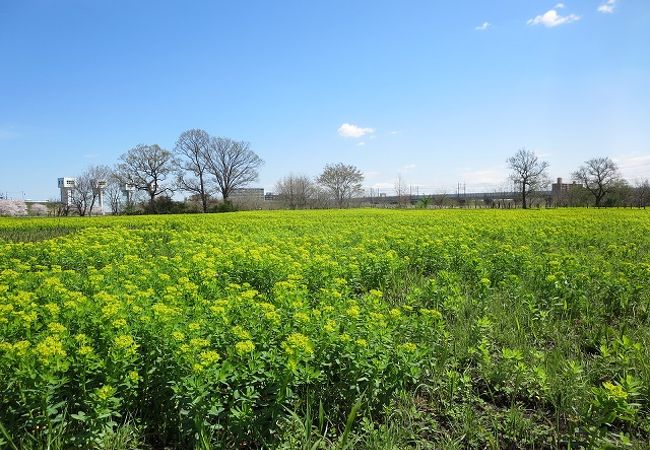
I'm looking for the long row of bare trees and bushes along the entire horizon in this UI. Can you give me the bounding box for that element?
[0,135,650,216]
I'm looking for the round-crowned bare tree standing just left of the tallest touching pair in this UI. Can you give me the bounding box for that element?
[116,144,174,213]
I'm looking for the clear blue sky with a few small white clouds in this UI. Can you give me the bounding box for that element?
[0,0,650,199]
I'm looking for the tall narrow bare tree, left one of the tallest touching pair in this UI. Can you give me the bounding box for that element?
[174,129,210,212]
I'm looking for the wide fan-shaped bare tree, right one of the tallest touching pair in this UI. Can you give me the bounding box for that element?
[205,137,264,202]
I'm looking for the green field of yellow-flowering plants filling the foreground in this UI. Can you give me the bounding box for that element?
[0,209,650,449]
